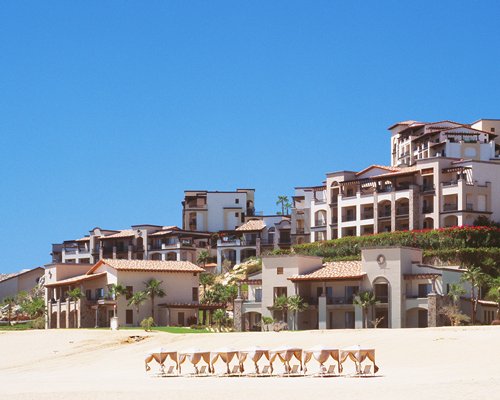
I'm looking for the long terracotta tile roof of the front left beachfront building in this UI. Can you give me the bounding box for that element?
[91,258,205,274]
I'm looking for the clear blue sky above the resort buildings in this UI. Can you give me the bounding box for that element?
[0,0,500,272]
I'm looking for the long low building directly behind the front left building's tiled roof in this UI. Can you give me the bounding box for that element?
[52,225,210,264]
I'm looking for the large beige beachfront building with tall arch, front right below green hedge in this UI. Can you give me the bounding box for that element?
[239,247,496,330]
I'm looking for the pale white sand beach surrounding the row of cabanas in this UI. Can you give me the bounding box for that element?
[0,327,500,400]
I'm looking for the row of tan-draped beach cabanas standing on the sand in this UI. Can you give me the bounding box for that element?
[145,346,379,377]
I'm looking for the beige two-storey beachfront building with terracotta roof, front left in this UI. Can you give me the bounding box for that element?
[45,259,215,328]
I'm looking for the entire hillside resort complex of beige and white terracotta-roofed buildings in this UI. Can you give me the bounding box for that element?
[0,119,500,331]
